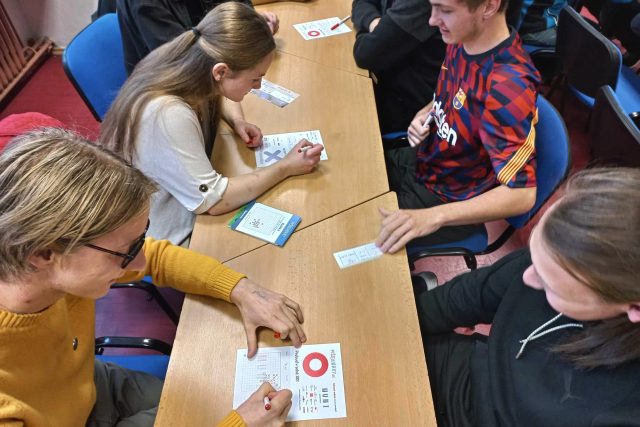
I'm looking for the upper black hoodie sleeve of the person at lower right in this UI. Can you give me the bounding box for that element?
[416,250,531,334]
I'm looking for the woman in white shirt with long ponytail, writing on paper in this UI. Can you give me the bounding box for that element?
[100,2,322,243]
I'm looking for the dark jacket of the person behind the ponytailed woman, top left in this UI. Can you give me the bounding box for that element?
[117,0,251,74]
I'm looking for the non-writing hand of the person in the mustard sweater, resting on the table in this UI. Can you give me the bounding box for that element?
[231,279,307,357]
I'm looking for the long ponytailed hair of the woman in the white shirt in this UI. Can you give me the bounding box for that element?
[100,2,275,161]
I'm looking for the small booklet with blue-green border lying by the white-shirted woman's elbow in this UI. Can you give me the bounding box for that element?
[229,201,301,246]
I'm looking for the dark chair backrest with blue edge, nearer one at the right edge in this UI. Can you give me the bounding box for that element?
[589,86,640,167]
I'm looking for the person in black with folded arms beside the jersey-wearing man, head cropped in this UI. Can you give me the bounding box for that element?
[351,0,445,134]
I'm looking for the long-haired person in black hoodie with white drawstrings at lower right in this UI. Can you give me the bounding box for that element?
[416,168,640,427]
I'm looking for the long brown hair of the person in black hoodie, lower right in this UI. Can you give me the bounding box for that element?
[541,168,640,368]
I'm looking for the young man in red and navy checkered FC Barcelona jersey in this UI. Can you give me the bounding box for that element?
[376,0,540,252]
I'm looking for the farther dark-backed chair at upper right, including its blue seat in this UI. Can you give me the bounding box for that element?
[556,7,640,114]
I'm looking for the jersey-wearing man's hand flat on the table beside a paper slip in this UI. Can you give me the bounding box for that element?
[376,208,442,253]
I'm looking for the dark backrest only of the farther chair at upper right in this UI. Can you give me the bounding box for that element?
[556,7,622,98]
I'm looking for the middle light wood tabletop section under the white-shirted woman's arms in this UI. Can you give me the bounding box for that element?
[191,52,389,262]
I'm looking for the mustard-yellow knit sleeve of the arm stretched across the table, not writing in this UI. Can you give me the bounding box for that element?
[118,237,246,302]
